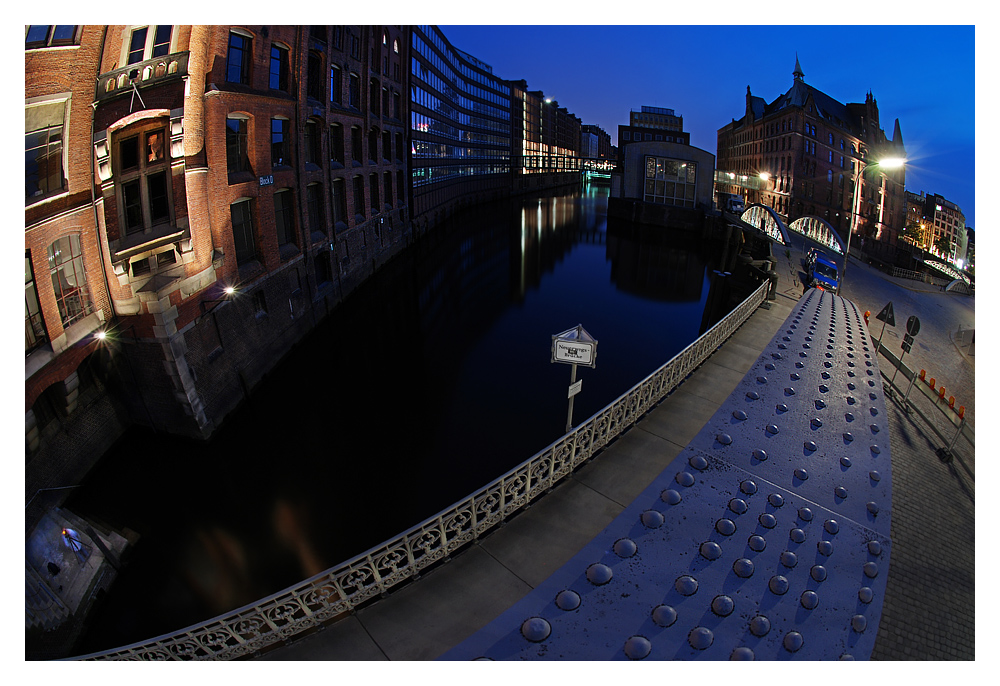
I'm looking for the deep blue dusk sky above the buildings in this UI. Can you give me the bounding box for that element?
[438,24,976,227]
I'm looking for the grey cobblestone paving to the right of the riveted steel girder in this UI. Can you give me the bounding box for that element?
[845,260,976,660]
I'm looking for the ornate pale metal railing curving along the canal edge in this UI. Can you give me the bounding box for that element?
[74,282,770,660]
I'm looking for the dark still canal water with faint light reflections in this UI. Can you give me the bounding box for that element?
[67,186,725,654]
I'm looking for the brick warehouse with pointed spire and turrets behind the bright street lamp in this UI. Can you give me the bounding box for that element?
[716,58,906,260]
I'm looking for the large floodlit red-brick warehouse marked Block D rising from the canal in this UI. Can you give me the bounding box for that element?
[25,26,410,510]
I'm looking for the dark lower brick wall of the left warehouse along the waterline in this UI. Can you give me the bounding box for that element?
[25,215,412,532]
